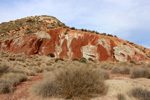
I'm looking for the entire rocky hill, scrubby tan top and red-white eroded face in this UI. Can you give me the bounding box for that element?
[0,16,150,61]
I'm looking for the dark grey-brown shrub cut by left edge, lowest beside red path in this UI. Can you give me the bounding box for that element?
[0,79,13,94]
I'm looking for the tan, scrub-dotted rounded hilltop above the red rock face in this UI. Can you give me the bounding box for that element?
[0,15,65,38]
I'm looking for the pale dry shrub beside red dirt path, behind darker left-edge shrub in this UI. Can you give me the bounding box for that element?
[1,72,27,86]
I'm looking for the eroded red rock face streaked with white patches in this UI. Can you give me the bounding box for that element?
[0,28,148,61]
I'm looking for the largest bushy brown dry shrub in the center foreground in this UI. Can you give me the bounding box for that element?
[33,66,108,99]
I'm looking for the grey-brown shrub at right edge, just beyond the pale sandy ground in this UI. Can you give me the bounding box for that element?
[131,68,150,78]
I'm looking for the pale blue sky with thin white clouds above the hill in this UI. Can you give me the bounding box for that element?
[0,0,150,48]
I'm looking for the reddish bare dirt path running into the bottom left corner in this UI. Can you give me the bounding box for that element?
[0,74,43,100]
